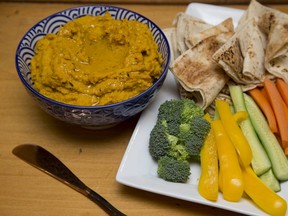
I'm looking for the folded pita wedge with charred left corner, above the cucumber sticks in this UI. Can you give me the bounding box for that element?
[212,14,267,85]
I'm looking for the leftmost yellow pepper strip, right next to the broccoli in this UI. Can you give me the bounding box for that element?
[198,114,218,201]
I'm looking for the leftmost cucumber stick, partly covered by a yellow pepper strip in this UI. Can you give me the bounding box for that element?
[229,85,271,176]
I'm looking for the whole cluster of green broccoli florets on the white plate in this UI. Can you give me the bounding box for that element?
[149,99,210,182]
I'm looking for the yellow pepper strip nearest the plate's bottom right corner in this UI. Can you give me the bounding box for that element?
[242,166,287,216]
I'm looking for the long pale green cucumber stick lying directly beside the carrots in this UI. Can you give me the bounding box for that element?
[243,93,288,181]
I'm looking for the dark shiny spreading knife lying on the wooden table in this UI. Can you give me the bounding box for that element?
[12,144,125,216]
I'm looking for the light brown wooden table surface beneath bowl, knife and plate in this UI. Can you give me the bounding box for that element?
[0,2,288,216]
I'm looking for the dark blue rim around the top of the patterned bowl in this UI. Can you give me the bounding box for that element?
[15,4,171,110]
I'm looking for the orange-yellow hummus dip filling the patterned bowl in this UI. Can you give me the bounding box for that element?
[31,13,163,106]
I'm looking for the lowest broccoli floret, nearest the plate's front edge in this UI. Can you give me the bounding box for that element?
[157,156,190,183]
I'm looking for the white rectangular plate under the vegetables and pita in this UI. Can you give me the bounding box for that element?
[116,3,288,215]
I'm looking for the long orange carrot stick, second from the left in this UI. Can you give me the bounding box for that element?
[263,79,288,149]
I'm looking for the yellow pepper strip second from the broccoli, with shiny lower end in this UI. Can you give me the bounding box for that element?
[211,120,244,202]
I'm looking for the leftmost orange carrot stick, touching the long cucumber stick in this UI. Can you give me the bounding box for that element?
[248,88,278,133]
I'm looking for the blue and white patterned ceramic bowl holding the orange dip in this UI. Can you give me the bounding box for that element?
[16,5,170,129]
